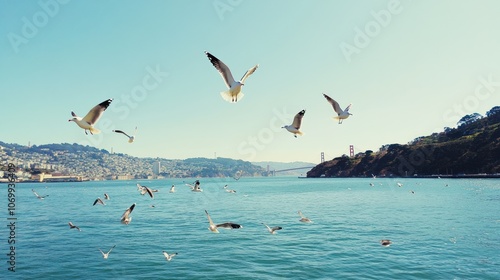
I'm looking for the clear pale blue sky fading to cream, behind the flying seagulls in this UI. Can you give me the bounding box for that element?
[0,0,500,163]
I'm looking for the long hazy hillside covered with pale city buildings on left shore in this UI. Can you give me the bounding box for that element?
[0,141,268,179]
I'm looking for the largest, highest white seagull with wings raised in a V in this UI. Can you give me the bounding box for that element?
[205,51,259,103]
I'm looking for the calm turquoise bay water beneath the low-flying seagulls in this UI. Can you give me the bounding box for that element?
[4,177,500,279]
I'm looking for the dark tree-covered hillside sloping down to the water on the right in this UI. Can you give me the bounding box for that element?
[307,106,500,177]
